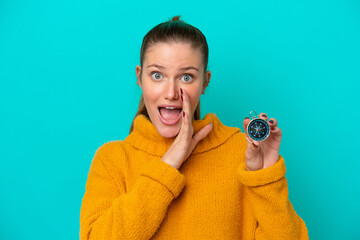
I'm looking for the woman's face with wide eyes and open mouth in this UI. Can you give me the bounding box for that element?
[136,42,211,138]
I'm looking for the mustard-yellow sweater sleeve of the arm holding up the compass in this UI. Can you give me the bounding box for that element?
[238,155,309,240]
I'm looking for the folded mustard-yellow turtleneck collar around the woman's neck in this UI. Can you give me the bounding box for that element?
[125,113,240,157]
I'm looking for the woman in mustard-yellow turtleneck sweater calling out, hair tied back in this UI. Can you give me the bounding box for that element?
[80,17,308,240]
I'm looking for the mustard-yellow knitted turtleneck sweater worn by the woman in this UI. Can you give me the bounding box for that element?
[80,113,308,240]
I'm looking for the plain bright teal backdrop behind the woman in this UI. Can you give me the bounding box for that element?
[0,0,360,240]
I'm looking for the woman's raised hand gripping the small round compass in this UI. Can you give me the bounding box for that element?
[243,113,282,171]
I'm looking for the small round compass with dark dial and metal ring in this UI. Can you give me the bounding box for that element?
[247,111,270,142]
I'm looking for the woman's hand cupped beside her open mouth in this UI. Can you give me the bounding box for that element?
[161,89,212,169]
